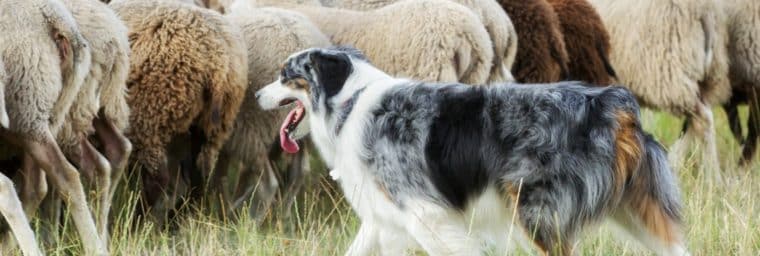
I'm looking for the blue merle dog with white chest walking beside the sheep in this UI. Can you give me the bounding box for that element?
[256,47,688,255]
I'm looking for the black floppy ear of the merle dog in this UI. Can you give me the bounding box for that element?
[309,51,353,98]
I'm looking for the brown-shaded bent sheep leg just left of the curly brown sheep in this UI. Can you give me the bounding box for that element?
[93,115,132,203]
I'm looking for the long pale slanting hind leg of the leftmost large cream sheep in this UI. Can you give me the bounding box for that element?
[24,131,107,255]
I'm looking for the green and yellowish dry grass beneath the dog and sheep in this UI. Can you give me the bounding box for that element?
[22,109,760,255]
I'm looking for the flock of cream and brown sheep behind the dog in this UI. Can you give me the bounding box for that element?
[0,0,760,255]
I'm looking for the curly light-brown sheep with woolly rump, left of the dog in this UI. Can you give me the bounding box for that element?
[110,0,248,222]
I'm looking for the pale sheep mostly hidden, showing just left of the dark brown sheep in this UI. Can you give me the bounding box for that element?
[320,0,517,84]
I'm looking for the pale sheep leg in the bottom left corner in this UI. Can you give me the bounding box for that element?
[0,174,42,256]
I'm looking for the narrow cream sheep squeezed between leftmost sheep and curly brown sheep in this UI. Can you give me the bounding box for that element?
[47,0,131,242]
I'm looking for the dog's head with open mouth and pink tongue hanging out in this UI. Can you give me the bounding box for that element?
[256,47,365,153]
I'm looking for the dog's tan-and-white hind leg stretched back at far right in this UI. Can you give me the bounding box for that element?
[612,204,689,256]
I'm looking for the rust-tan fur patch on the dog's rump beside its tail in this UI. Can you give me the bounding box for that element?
[613,111,642,196]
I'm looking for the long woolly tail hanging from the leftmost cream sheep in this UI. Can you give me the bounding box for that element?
[40,1,92,134]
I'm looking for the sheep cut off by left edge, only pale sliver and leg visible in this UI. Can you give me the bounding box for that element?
[0,59,42,255]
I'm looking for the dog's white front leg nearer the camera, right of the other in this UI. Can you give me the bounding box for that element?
[405,202,483,255]
